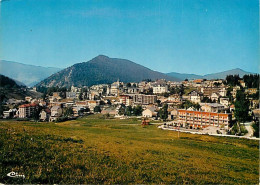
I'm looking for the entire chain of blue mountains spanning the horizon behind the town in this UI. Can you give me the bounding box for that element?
[0,55,252,87]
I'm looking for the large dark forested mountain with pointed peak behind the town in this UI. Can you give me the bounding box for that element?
[37,55,180,87]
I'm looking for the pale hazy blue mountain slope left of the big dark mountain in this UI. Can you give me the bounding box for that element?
[0,60,61,87]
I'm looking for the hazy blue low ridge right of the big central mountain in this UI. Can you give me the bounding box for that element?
[166,68,253,80]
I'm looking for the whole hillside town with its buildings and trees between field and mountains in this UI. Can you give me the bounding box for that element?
[2,76,260,136]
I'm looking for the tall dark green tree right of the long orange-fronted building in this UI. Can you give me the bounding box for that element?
[234,91,250,123]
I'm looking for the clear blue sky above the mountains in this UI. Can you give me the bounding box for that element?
[0,0,259,74]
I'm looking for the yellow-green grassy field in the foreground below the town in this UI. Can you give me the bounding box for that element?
[0,115,259,184]
